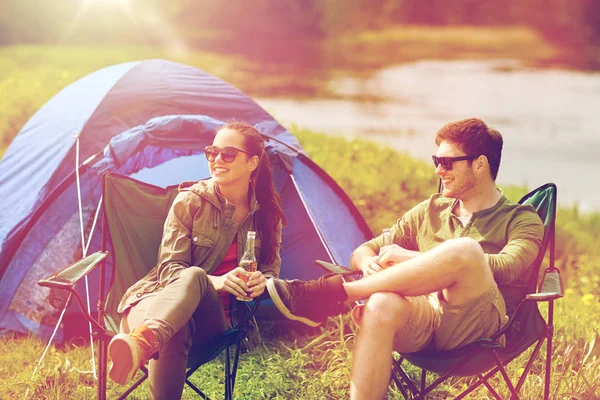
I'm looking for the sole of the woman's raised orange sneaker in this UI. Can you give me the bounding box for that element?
[108,333,139,385]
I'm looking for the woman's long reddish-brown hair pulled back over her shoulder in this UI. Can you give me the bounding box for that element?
[219,121,286,264]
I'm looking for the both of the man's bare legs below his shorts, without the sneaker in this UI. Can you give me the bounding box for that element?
[344,238,494,400]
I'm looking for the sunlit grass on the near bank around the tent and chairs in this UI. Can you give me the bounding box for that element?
[0,128,600,400]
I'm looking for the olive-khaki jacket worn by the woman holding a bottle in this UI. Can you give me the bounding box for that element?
[118,179,281,349]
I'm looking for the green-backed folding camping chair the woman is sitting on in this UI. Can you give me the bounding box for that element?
[38,173,259,400]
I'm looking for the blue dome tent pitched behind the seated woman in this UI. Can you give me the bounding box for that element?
[0,60,371,337]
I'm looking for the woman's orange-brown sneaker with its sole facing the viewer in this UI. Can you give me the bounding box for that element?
[108,325,160,385]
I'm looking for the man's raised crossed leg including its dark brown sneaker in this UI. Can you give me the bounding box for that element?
[267,238,495,344]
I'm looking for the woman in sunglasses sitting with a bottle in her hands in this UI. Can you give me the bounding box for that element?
[108,122,284,399]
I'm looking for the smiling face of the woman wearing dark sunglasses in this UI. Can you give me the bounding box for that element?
[208,128,258,186]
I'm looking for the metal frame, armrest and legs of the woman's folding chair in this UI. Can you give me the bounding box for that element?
[38,175,260,400]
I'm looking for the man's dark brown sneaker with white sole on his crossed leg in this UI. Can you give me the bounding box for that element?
[267,275,347,327]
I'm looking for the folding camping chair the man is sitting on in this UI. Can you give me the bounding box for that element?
[321,183,564,399]
